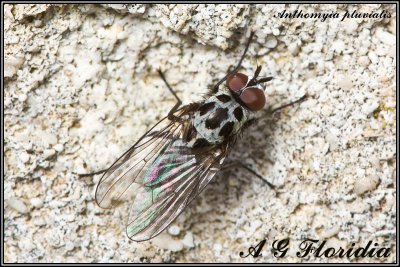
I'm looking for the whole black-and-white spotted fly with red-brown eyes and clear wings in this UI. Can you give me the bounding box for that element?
[82,33,305,241]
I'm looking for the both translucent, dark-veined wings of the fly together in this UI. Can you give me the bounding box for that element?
[96,106,230,241]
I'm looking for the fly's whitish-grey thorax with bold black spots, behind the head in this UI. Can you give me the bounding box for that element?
[193,92,249,147]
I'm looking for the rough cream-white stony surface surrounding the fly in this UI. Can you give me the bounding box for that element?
[4,4,397,262]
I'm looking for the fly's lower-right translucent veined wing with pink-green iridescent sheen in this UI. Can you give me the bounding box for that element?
[127,139,228,241]
